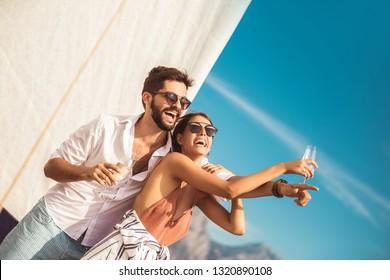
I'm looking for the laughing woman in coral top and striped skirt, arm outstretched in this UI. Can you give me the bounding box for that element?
[82,112,318,259]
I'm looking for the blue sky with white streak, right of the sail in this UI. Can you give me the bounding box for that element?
[191,0,390,260]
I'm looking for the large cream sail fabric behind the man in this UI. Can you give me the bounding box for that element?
[0,0,250,223]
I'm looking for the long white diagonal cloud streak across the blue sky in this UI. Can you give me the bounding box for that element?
[206,75,390,230]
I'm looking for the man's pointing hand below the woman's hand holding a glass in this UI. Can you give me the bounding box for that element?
[277,183,319,206]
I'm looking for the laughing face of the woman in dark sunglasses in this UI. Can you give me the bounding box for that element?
[177,116,213,156]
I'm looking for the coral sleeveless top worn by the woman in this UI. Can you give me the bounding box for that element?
[140,187,193,246]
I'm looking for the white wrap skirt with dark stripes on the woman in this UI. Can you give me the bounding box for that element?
[81,210,170,260]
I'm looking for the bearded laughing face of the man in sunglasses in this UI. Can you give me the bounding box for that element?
[150,81,187,131]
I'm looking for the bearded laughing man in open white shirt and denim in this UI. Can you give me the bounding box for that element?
[0,66,201,259]
